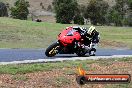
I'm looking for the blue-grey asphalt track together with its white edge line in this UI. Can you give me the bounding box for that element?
[0,49,132,64]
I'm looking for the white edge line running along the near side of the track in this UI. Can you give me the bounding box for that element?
[0,55,132,65]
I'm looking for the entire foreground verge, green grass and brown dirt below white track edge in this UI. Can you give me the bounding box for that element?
[0,58,132,88]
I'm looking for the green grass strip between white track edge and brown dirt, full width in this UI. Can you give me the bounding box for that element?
[0,58,132,75]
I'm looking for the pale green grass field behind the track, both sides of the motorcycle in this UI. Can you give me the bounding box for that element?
[0,17,132,48]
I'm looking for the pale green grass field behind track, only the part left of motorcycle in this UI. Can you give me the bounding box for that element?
[0,18,71,48]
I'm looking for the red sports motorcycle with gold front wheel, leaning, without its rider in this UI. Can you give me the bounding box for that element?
[45,27,94,57]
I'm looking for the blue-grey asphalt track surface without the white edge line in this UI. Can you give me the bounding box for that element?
[0,49,132,62]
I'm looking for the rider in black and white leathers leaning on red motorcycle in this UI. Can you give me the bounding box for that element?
[73,26,100,56]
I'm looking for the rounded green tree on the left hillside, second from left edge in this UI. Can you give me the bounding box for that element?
[11,0,29,20]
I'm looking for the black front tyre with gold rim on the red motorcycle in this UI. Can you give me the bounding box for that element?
[45,42,60,57]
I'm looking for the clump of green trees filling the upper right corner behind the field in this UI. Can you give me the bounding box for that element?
[80,0,132,26]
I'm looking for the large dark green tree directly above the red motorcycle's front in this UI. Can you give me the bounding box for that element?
[53,0,78,24]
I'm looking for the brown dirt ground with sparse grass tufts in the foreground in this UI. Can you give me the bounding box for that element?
[0,61,132,88]
